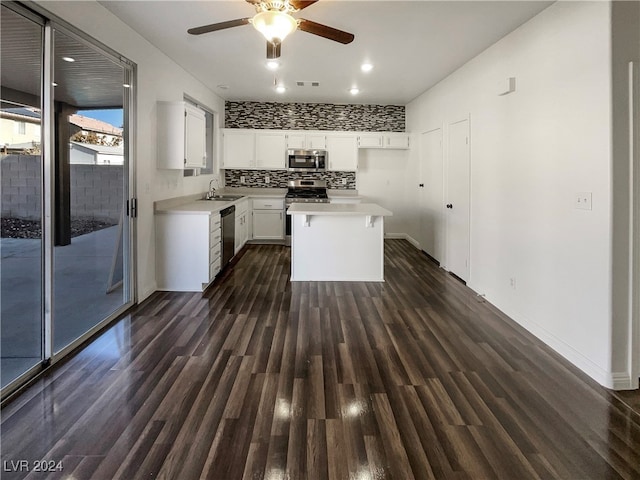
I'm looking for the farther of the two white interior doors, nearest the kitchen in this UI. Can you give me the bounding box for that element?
[418,128,445,262]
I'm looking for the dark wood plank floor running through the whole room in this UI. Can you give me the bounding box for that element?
[1,240,640,480]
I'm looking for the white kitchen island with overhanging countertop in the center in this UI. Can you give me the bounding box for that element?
[287,203,392,282]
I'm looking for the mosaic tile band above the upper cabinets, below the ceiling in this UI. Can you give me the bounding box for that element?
[224,102,405,132]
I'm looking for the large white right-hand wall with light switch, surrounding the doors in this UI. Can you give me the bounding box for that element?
[407,2,617,386]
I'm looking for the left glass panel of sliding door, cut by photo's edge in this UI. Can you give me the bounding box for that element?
[0,6,44,388]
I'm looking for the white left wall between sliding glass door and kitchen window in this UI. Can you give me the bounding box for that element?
[37,0,224,301]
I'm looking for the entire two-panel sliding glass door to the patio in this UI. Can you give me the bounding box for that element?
[0,4,135,397]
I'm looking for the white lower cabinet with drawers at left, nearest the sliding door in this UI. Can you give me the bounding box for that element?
[155,212,222,292]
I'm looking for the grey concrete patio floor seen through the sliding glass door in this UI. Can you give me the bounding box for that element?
[0,226,125,387]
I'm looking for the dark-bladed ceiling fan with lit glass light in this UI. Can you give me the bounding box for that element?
[187,0,355,59]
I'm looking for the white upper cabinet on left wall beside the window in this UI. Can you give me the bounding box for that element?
[157,102,207,170]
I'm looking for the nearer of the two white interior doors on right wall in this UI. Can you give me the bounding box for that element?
[445,119,470,281]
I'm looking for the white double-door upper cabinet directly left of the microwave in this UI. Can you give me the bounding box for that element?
[222,128,287,169]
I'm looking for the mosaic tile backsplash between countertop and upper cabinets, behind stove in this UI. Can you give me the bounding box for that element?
[224,170,356,190]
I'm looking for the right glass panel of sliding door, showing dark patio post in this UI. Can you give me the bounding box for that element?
[53,28,130,353]
